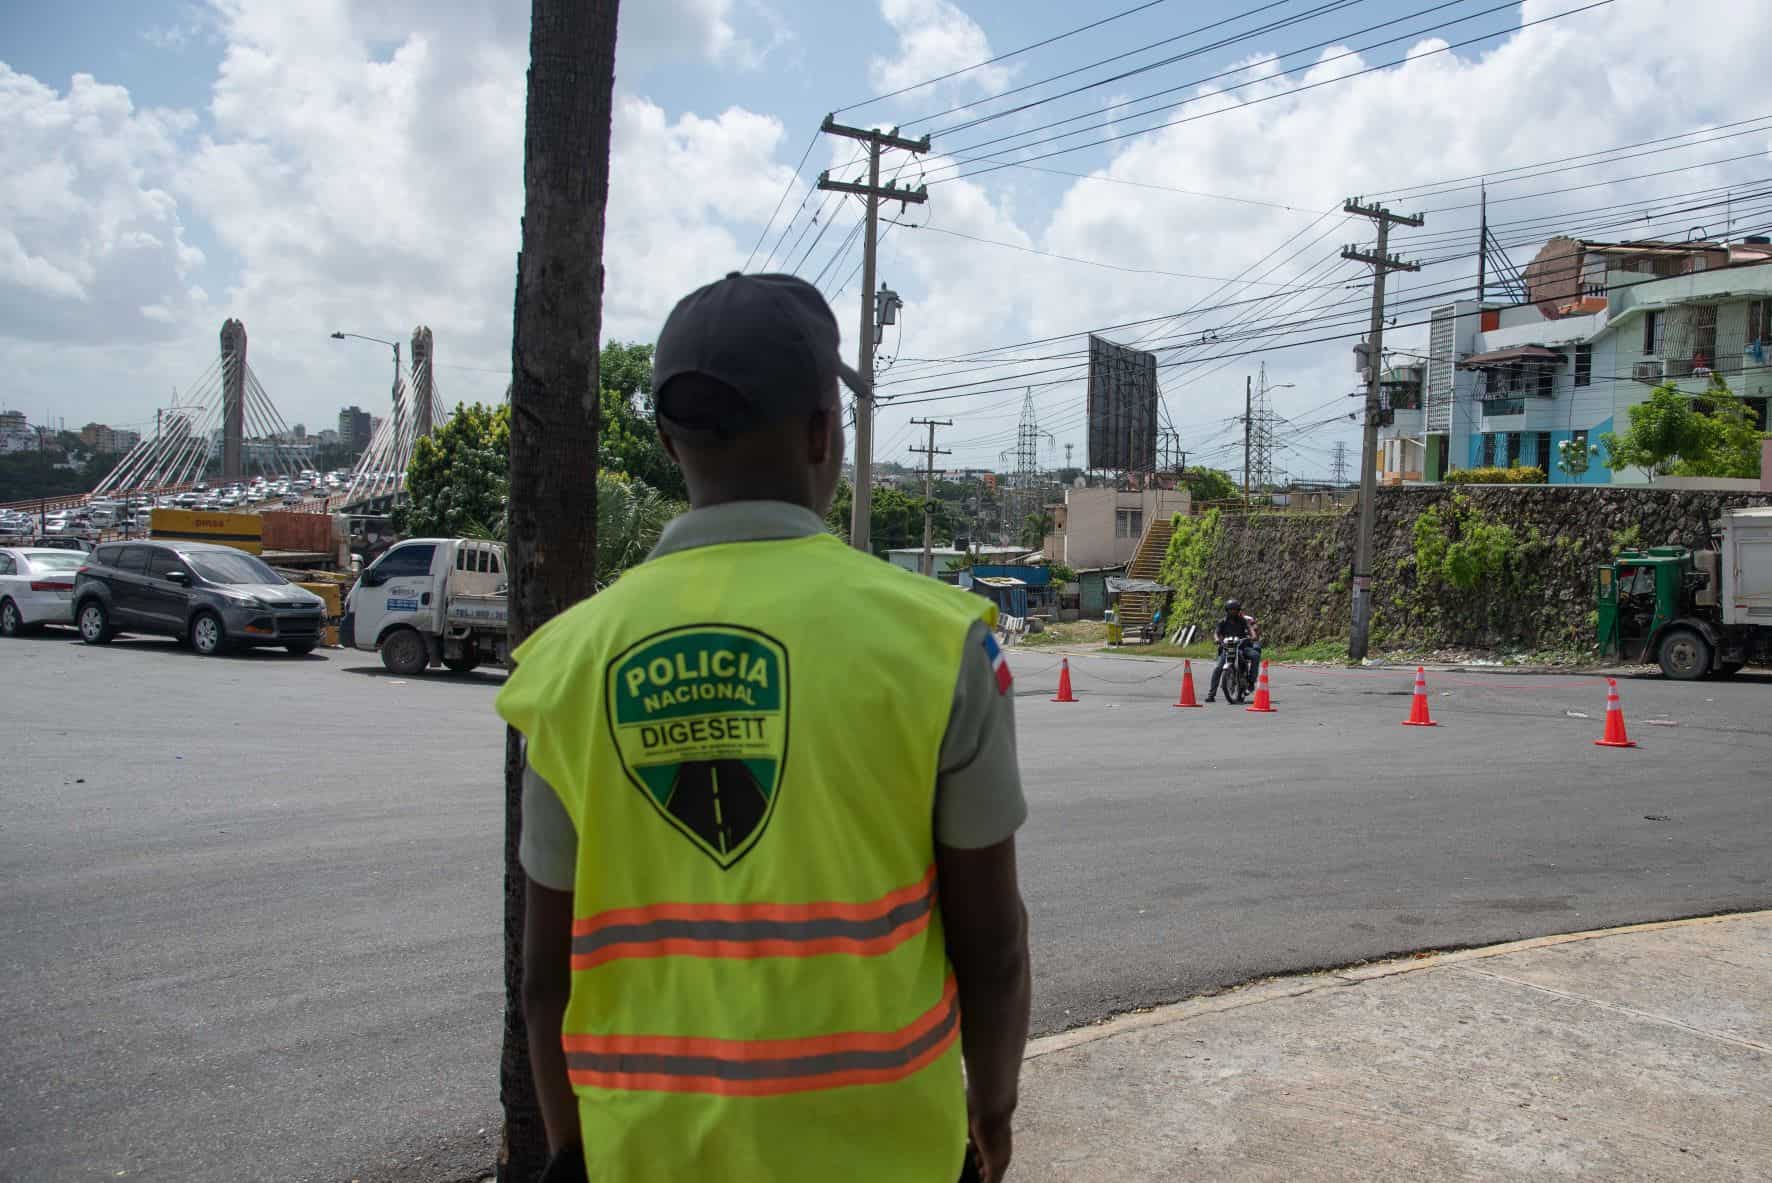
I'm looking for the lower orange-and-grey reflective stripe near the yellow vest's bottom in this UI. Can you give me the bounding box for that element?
[562,978,960,1096]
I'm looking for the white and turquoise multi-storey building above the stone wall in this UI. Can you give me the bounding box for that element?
[1379,239,1772,485]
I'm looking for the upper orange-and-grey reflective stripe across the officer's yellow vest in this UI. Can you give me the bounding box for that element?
[572,868,936,969]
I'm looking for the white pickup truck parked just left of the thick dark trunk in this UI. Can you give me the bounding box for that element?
[338,538,510,677]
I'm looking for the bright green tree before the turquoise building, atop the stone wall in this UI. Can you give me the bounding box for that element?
[1600,375,1763,476]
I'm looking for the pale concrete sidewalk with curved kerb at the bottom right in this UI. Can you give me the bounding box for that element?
[1010,912,1772,1183]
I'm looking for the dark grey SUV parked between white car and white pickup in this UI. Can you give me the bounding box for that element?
[74,542,326,655]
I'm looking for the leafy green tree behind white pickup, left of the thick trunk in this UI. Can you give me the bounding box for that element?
[393,402,510,538]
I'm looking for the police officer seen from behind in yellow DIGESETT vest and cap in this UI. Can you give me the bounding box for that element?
[498,274,1030,1183]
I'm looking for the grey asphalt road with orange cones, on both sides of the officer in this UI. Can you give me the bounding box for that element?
[0,634,1772,1183]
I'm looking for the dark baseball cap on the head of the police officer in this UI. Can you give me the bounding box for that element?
[652,271,868,441]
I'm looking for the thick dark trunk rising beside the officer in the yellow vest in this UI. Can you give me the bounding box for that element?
[498,0,618,1183]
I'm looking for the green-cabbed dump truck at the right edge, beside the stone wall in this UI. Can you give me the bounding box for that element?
[1595,506,1772,680]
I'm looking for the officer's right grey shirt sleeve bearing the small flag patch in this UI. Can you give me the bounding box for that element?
[936,622,1028,850]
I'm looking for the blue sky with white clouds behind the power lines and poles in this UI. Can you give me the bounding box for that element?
[0,0,1772,476]
